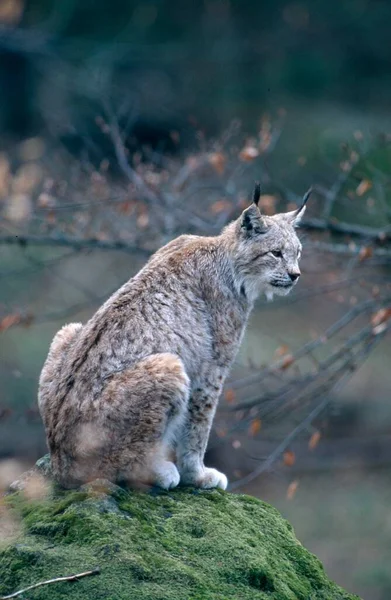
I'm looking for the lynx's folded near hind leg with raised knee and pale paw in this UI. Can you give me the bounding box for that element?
[102,353,190,489]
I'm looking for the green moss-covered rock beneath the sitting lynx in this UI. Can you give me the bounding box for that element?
[0,458,357,600]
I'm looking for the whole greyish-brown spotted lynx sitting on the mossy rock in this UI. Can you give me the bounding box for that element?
[38,185,310,489]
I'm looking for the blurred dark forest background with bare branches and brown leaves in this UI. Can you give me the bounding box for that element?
[0,0,391,600]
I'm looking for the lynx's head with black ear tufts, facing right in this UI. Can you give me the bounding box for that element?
[234,184,311,300]
